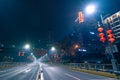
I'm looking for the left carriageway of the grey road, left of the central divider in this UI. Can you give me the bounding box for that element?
[0,63,39,80]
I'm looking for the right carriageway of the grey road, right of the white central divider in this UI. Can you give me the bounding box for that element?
[41,64,115,80]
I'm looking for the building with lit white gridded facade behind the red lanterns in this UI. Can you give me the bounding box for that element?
[104,11,120,43]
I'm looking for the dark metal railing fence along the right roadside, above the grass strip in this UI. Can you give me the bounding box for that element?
[66,63,120,73]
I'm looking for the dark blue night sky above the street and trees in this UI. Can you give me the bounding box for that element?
[0,0,120,42]
